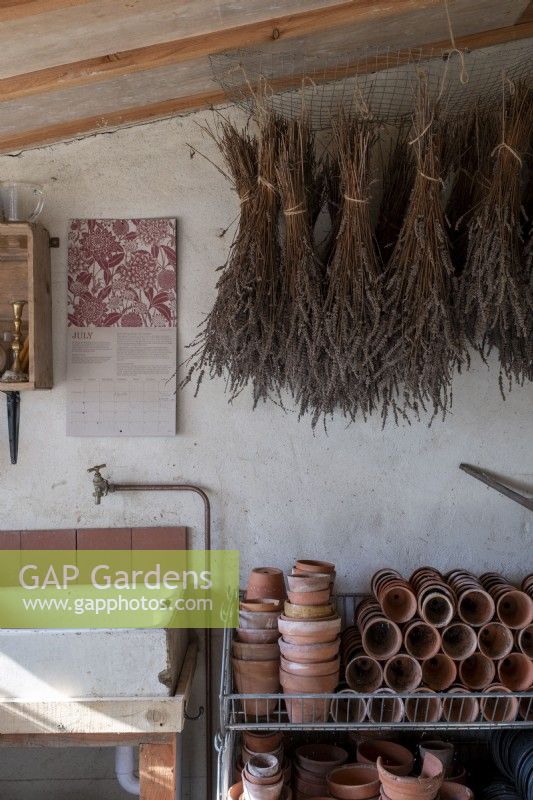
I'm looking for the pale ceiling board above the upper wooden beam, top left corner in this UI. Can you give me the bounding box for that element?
[0,0,408,78]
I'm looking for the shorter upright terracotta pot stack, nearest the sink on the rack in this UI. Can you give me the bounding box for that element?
[231,567,285,720]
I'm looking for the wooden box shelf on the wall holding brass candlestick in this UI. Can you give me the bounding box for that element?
[0,222,53,392]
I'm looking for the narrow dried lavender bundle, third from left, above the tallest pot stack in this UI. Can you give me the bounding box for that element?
[276,119,325,427]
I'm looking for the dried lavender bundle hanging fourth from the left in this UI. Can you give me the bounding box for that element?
[324,115,386,420]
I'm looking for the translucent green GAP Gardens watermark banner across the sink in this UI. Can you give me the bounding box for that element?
[0,550,239,628]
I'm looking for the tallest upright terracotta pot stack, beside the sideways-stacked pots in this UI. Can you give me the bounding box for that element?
[278,560,341,723]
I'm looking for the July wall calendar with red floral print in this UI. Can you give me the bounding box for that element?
[67,219,176,436]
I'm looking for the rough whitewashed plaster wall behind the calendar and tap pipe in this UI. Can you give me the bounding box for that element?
[0,109,533,800]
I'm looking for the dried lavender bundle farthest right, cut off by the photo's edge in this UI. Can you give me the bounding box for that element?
[460,85,533,394]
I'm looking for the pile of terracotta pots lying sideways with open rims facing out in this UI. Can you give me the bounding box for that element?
[341,567,533,723]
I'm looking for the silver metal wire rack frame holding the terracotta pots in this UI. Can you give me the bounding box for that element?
[215,594,533,800]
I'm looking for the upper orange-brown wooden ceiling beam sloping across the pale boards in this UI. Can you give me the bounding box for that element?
[0,0,442,102]
